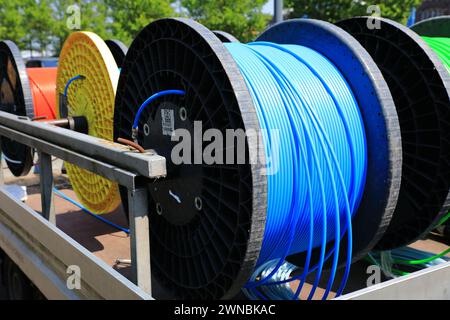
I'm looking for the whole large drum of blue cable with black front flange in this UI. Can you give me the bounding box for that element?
[114,19,401,299]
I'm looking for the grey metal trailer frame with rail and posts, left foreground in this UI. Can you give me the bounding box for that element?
[0,112,166,298]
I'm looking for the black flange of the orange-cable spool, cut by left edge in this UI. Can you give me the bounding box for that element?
[0,40,34,177]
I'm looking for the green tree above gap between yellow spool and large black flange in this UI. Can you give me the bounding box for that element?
[105,0,175,45]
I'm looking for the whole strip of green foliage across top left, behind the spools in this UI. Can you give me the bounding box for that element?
[0,0,174,54]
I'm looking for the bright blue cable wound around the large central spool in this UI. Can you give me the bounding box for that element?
[225,42,367,299]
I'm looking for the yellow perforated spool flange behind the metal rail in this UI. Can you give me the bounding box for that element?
[56,32,120,214]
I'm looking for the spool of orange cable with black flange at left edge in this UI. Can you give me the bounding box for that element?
[0,40,56,176]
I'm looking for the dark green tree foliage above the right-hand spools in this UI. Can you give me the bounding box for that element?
[286,0,422,23]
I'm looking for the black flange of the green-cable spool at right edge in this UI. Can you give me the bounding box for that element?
[337,17,450,250]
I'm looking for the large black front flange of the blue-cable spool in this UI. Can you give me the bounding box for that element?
[114,19,267,299]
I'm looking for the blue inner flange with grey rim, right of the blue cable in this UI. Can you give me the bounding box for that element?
[257,19,402,266]
